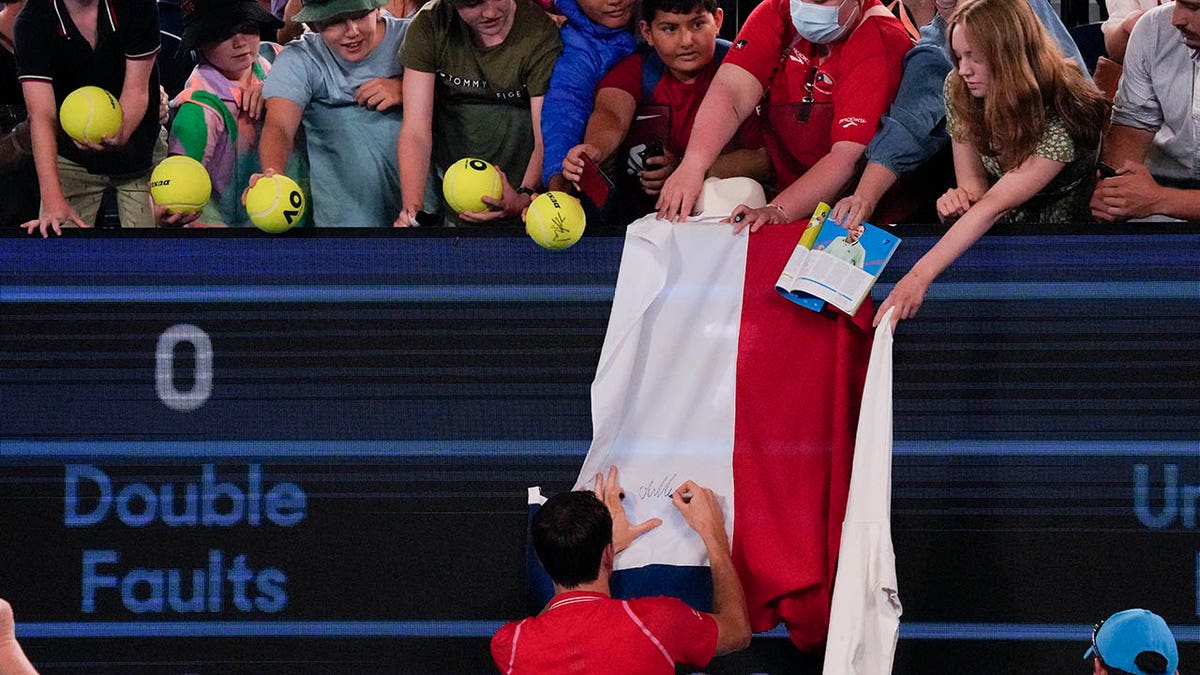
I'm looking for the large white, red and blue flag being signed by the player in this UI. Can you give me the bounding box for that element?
[577,215,874,651]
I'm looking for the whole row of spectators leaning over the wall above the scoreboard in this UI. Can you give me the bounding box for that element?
[0,0,1200,252]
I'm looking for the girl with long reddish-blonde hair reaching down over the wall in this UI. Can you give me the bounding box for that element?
[875,0,1109,323]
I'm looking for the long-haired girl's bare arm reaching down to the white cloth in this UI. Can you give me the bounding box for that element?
[875,148,1067,324]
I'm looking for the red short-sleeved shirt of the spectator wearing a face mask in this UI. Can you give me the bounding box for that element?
[724,0,912,187]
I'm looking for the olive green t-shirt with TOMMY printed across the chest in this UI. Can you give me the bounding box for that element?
[400,0,563,187]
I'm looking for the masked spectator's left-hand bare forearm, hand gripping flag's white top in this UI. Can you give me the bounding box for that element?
[656,64,762,220]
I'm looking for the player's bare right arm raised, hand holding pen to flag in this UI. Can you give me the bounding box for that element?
[671,480,750,656]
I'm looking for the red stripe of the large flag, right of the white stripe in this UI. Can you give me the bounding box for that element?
[733,221,875,651]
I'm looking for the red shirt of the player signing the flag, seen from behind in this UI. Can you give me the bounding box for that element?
[492,591,716,675]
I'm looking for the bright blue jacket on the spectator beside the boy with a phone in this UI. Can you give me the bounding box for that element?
[541,0,635,184]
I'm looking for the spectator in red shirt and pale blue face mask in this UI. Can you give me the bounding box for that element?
[658,0,912,227]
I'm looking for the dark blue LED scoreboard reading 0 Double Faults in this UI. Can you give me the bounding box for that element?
[0,226,1200,673]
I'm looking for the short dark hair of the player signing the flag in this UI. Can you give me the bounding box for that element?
[533,490,612,589]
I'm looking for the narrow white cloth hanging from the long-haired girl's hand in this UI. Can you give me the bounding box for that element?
[823,310,902,675]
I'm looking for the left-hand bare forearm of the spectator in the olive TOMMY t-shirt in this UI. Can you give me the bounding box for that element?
[395,68,434,227]
